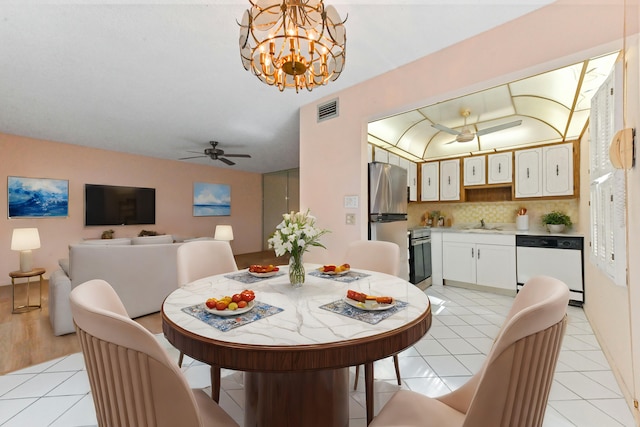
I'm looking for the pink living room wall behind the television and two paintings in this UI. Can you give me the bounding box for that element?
[0,134,262,284]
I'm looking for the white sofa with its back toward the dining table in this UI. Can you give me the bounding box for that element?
[49,236,181,335]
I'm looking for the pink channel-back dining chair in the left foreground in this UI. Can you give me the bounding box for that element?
[70,279,238,427]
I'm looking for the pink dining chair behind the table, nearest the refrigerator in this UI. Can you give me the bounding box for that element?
[345,240,402,390]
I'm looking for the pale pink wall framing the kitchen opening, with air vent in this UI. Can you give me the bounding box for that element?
[300,0,640,421]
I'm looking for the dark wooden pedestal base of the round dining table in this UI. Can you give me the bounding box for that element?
[244,368,349,427]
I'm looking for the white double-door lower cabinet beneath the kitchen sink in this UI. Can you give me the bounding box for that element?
[442,233,516,292]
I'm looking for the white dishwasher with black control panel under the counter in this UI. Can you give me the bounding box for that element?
[516,235,584,307]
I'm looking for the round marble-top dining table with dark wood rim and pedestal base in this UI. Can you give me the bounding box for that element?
[162,264,431,427]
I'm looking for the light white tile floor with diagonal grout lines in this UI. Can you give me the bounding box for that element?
[0,286,634,427]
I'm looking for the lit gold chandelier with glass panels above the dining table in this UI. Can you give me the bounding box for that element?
[239,0,347,92]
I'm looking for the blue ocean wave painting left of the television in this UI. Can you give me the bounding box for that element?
[7,176,69,218]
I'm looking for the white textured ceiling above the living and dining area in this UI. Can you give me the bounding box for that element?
[0,0,551,173]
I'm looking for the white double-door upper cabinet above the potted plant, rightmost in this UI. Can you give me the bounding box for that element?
[516,142,573,197]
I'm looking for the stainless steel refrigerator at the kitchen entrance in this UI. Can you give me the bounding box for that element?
[369,162,409,280]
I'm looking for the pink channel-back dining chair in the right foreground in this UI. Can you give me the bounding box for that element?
[369,276,569,427]
